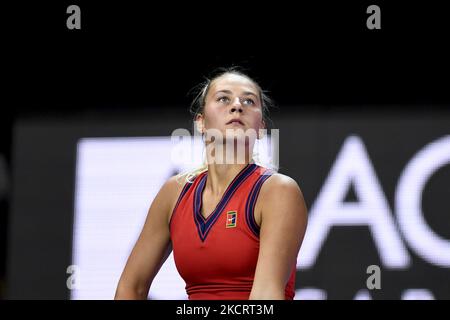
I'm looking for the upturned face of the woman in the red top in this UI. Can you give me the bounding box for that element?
[197,74,265,136]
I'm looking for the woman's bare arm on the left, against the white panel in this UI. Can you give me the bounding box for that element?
[116,177,186,299]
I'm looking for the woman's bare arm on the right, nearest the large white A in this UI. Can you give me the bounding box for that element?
[250,174,307,299]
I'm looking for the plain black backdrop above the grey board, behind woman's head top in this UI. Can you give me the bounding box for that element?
[3,1,448,118]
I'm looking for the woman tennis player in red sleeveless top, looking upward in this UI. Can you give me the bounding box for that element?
[115,69,307,300]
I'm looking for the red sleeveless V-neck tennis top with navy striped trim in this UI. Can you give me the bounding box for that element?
[169,164,296,300]
